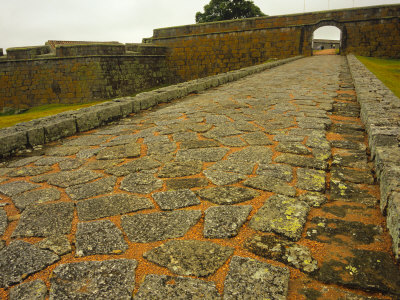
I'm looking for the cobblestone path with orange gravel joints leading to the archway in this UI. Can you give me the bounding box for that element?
[0,56,400,299]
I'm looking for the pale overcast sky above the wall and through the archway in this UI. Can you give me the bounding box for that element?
[0,0,400,50]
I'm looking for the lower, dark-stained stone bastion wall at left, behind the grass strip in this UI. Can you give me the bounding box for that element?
[0,45,173,110]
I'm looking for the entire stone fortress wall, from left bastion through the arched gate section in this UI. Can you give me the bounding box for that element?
[0,5,400,111]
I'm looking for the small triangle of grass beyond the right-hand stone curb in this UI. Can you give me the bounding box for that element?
[357,56,400,98]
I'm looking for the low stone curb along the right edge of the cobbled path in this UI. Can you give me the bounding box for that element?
[347,55,400,260]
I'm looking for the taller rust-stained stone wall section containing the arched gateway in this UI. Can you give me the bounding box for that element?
[144,5,400,80]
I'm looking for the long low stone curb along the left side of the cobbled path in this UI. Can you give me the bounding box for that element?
[0,56,302,157]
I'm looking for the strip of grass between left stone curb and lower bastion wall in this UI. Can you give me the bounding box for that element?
[0,101,104,128]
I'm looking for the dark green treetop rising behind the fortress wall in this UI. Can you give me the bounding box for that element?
[196,0,265,23]
